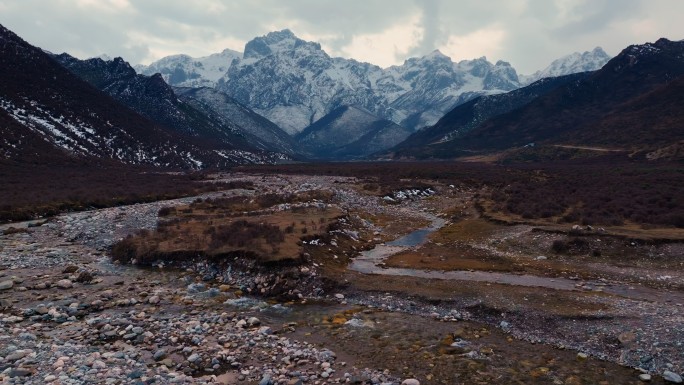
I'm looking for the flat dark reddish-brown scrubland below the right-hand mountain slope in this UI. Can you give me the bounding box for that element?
[242,157,684,228]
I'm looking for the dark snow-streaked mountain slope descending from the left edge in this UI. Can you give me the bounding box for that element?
[0,26,232,168]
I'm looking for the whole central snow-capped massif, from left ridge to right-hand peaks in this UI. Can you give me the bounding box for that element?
[143,30,520,135]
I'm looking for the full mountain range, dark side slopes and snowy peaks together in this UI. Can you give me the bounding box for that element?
[0,21,684,169]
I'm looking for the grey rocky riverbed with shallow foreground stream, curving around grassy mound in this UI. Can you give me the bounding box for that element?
[0,172,684,385]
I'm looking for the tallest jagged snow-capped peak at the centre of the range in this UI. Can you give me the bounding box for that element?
[217,30,387,134]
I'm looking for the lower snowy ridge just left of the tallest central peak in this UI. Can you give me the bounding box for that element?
[135,49,242,87]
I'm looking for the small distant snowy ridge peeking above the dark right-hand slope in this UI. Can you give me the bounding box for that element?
[520,47,611,85]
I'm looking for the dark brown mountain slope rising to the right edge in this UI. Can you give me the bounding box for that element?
[390,39,684,159]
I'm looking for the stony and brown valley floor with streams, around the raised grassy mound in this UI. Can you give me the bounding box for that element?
[0,174,684,385]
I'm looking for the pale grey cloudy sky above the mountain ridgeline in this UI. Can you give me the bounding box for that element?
[0,0,684,74]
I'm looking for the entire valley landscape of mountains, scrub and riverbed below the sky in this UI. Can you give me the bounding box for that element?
[0,20,684,385]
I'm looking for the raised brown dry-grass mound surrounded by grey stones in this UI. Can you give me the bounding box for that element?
[112,192,344,263]
